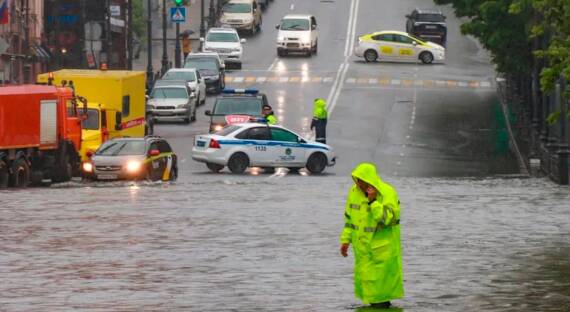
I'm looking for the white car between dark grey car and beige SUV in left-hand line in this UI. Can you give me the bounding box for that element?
[200,28,245,69]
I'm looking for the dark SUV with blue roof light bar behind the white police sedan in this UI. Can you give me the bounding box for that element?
[206,89,269,132]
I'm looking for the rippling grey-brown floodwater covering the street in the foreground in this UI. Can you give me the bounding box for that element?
[0,173,570,311]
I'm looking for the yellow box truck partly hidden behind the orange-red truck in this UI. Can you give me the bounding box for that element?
[37,69,152,161]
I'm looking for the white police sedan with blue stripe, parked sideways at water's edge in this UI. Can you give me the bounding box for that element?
[192,122,335,174]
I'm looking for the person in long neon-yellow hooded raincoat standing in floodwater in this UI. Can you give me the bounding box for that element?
[340,163,404,307]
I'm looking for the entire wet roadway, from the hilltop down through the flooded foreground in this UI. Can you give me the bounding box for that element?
[0,0,570,311]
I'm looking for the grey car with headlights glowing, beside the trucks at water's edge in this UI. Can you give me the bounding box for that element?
[82,136,178,181]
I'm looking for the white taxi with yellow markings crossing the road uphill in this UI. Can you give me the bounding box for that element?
[354,31,445,64]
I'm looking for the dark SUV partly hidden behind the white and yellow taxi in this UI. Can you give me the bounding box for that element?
[406,9,447,46]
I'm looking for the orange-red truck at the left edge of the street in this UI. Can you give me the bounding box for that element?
[0,85,87,188]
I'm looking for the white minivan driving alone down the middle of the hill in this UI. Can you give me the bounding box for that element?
[275,14,319,56]
